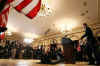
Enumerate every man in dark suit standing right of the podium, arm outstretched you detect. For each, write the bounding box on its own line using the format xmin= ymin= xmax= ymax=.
xmin=81 ymin=23 xmax=96 ymax=65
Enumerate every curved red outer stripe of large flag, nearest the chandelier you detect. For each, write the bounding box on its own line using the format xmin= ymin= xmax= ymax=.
xmin=26 ymin=0 xmax=41 ymax=19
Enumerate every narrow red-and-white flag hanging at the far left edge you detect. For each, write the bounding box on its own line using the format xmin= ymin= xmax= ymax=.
xmin=0 ymin=0 xmax=13 ymax=39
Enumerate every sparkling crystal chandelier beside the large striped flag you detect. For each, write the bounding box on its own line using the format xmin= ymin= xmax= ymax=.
xmin=38 ymin=0 xmax=52 ymax=16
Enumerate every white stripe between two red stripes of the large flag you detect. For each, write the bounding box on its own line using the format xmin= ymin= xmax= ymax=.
xmin=22 ymin=0 xmax=39 ymax=14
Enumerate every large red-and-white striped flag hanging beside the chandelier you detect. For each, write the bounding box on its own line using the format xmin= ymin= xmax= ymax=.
xmin=11 ymin=0 xmax=41 ymax=19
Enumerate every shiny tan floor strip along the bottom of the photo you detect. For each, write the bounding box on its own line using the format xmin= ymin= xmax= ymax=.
xmin=0 ymin=59 xmax=95 ymax=66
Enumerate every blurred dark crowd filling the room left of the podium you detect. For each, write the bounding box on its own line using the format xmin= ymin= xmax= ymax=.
xmin=0 ymin=40 xmax=63 ymax=63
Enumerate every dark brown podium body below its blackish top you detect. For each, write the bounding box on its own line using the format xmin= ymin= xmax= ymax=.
xmin=63 ymin=44 xmax=75 ymax=64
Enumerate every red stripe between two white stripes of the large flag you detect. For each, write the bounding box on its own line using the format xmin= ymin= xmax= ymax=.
xmin=15 ymin=0 xmax=33 ymax=12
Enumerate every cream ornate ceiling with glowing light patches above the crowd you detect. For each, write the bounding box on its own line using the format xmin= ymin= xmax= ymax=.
xmin=7 ymin=0 xmax=98 ymax=38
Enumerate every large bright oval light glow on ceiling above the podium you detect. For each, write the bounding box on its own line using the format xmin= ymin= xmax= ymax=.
xmin=56 ymin=19 xmax=77 ymax=32
